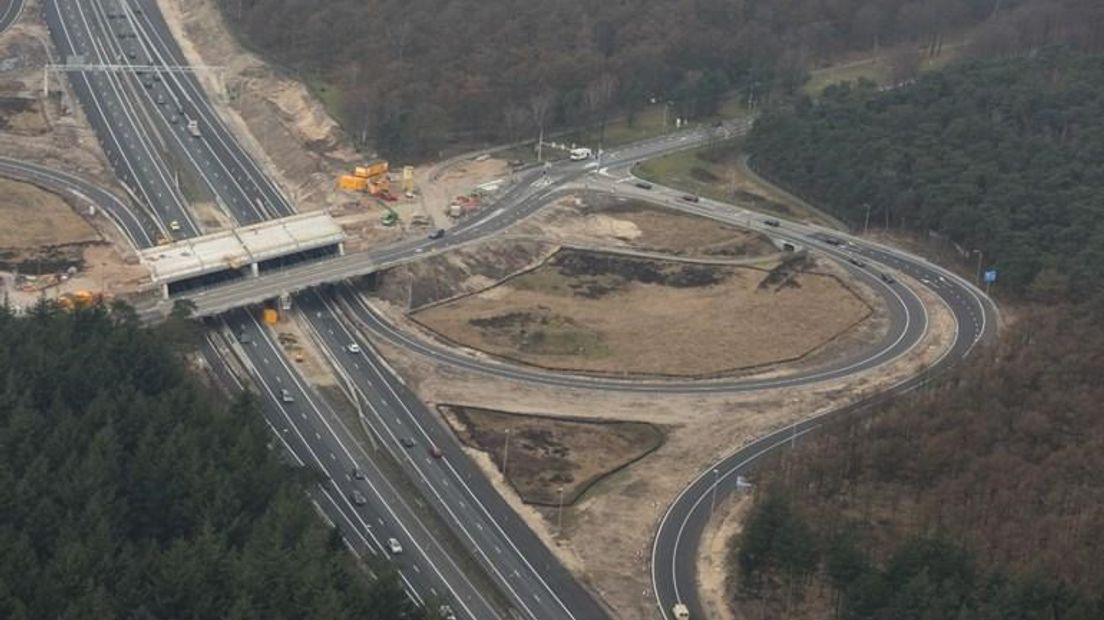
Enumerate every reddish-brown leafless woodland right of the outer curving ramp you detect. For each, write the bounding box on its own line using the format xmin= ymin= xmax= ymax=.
xmin=730 ymin=300 xmax=1104 ymax=620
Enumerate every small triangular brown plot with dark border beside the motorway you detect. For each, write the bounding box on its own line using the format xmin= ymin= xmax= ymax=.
xmin=437 ymin=405 xmax=664 ymax=506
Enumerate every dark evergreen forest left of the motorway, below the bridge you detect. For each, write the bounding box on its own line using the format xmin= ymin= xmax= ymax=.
xmin=0 ymin=306 xmax=422 ymax=620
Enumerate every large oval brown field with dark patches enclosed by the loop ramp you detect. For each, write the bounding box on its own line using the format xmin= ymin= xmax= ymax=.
xmin=412 ymin=249 xmax=872 ymax=376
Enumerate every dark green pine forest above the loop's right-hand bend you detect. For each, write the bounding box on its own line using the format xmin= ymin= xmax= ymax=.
xmin=749 ymin=49 xmax=1104 ymax=301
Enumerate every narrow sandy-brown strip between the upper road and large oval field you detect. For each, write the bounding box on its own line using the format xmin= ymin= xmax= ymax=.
xmin=519 ymin=194 xmax=778 ymax=258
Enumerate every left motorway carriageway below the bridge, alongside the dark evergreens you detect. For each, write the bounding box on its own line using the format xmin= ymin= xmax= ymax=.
xmin=204 ymin=310 xmax=508 ymax=618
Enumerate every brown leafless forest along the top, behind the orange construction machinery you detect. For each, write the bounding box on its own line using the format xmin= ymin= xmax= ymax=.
xmin=219 ymin=0 xmax=1002 ymax=156
